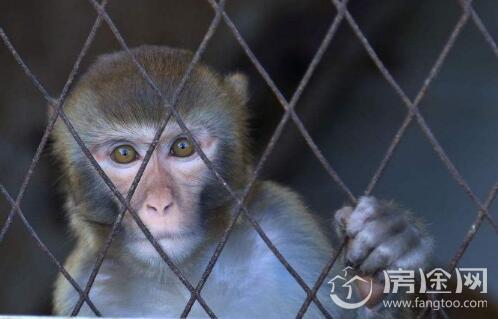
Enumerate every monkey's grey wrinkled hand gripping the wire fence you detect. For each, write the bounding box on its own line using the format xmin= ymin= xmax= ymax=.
xmin=335 ymin=197 xmax=432 ymax=307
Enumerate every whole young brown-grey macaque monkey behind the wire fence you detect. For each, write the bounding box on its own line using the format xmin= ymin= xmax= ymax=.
xmin=53 ymin=46 xmax=431 ymax=318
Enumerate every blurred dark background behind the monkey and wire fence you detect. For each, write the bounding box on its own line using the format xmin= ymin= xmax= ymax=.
xmin=0 ymin=0 xmax=498 ymax=314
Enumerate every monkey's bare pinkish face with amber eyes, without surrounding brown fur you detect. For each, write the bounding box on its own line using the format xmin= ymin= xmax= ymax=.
xmin=92 ymin=124 xmax=218 ymax=258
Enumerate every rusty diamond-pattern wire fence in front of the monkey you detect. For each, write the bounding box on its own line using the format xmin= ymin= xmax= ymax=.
xmin=0 ymin=0 xmax=498 ymax=318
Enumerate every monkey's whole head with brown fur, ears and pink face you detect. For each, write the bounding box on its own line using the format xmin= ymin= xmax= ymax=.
xmin=53 ymin=46 xmax=250 ymax=259
